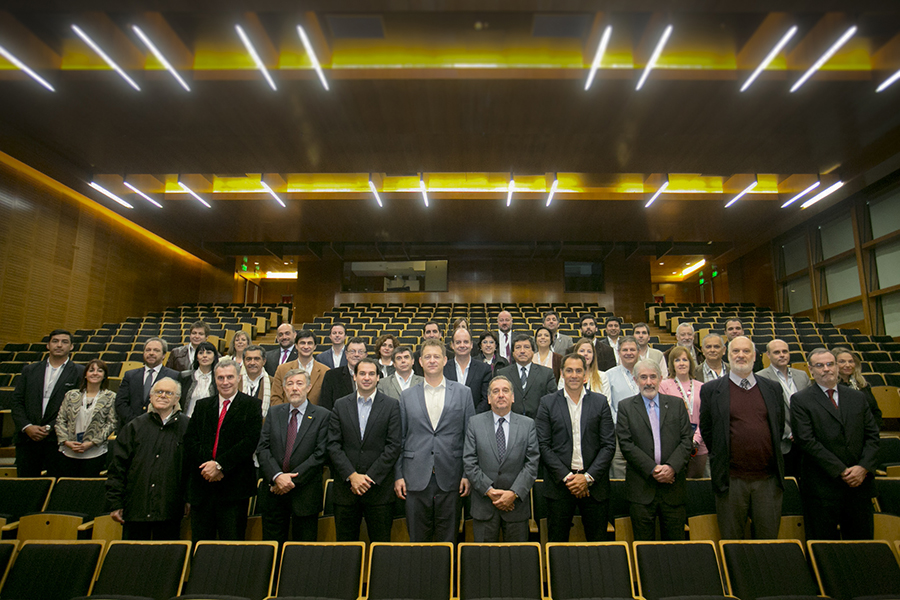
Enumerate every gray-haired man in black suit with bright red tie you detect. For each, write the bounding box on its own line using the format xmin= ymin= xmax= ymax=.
xmin=184 ymin=358 xmax=262 ymax=543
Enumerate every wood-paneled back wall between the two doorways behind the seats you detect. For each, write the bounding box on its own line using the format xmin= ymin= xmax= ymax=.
xmin=284 ymin=251 xmax=653 ymax=324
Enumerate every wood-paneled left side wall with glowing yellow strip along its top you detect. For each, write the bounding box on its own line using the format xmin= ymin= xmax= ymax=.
xmin=0 ymin=155 xmax=234 ymax=348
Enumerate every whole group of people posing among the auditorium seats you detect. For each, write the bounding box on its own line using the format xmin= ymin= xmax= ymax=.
xmin=13 ymin=311 xmax=880 ymax=542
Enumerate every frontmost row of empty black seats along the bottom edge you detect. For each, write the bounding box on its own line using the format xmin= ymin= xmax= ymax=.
xmin=0 ymin=540 xmax=900 ymax=600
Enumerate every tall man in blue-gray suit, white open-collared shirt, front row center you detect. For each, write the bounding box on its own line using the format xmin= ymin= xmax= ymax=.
xmin=394 ymin=339 xmax=475 ymax=542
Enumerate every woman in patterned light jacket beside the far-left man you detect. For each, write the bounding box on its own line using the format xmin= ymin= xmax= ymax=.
xmin=56 ymin=358 xmax=116 ymax=477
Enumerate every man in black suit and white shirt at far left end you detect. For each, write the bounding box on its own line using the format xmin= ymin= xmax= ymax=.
xmin=10 ymin=329 xmax=84 ymax=477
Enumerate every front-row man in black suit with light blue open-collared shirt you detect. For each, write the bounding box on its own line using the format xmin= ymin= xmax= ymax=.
xmin=328 ymin=358 xmax=402 ymax=542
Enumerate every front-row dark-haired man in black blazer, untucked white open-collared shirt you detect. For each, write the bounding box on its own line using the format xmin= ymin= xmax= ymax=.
xmin=536 ymin=354 xmax=616 ymax=542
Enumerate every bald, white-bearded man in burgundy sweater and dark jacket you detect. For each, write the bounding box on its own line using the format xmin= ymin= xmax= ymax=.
xmin=700 ymin=336 xmax=784 ymax=540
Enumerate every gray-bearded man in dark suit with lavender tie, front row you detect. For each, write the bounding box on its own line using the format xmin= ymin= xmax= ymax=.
xmin=616 ymin=359 xmax=694 ymax=541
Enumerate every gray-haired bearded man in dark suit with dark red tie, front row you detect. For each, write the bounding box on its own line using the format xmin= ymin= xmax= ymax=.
xmin=256 ymin=369 xmax=331 ymax=543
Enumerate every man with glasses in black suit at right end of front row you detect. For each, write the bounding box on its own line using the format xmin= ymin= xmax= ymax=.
xmin=791 ymin=348 xmax=879 ymax=540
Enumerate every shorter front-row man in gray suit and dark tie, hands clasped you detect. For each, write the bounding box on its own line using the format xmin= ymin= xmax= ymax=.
xmin=463 ymin=375 xmax=541 ymax=542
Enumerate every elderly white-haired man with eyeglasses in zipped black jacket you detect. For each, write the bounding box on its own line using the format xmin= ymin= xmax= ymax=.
xmin=106 ymin=377 xmax=190 ymax=540
